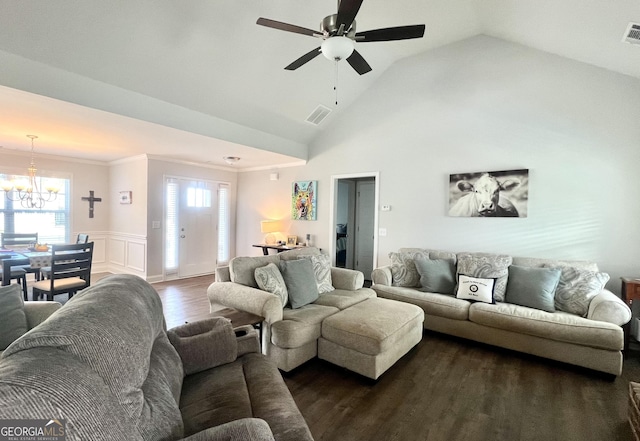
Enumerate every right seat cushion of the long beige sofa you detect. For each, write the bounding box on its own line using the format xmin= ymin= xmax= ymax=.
xmin=469 ymin=303 xmax=624 ymax=351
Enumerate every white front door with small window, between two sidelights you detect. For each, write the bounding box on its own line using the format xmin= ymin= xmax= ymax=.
xmin=177 ymin=179 xmax=218 ymax=278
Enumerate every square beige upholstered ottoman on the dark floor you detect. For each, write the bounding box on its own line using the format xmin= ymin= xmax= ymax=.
xmin=318 ymin=298 xmax=424 ymax=380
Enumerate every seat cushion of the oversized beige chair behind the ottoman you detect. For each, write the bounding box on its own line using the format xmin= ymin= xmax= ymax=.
xmin=271 ymin=304 xmax=340 ymax=349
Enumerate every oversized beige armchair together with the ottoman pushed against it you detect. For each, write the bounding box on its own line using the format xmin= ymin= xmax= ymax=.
xmin=208 ymin=248 xmax=424 ymax=379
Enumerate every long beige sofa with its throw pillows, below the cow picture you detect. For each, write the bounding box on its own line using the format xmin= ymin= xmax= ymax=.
xmin=372 ymin=248 xmax=631 ymax=375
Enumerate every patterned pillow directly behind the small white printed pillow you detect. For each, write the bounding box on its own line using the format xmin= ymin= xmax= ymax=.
xmin=457 ymin=253 xmax=512 ymax=302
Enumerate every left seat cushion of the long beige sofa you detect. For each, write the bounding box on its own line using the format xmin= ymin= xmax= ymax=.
xmin=372 ymin=285 xmax=470 ymax=320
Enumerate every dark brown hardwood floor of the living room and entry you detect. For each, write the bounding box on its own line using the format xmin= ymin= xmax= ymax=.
xmin=27 ymin=276 xmax=640 ymax=441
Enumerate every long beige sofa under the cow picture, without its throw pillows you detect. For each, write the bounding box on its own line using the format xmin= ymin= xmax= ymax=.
xmin=372 ymin=248 xmax=631 ymax=375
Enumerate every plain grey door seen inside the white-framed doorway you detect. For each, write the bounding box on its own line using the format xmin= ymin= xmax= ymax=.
xmin=354 ymin=180 xmax=375 ymax=280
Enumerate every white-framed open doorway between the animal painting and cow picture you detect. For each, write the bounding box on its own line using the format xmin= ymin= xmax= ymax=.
xmin=330 ymin=173 xmax=378 ymax=282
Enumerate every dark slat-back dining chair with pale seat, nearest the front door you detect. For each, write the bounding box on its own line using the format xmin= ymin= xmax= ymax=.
xmin=33 ymin=242 xmax=93 ymax=300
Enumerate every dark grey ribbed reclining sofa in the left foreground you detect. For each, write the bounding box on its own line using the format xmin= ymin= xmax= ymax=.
xmin=0 ymin=275 xmax=313 ymax=441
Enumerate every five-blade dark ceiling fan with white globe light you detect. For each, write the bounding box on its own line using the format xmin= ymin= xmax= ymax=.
xmin=256 ymin=0 xmax=425 ymax=75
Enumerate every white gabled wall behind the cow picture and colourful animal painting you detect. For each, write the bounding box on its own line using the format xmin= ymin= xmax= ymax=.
xmin=237 ymin=36 xmax=640 ymax=292
